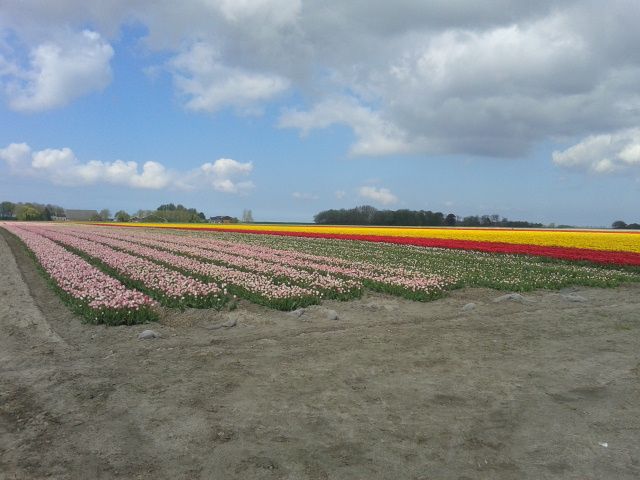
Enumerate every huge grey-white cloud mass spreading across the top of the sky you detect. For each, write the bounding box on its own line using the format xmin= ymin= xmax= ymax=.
xmin=0 ymin=0 xmax=640 ymax=161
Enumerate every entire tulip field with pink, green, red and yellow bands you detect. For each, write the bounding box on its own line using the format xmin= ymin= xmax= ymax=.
xmin=0 ymin=222 xmax=640 ymax=324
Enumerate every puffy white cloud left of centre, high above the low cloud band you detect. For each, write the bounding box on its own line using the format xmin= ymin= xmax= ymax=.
xmin=170 ymin=42 xmax=289 ymax=113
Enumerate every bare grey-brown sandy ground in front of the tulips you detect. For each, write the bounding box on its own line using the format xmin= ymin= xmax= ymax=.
xmin=0 ymin=229 xmax=640 ymax=480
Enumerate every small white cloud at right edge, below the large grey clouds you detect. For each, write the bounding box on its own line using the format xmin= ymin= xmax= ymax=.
xmin=553 ymin=128 xmax=640 ymax=173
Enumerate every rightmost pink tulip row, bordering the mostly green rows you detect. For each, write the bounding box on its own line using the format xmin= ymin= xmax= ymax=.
xmin=97 ymin=228 xmax=456 ymax=296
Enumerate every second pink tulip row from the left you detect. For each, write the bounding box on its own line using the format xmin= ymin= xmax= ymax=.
xmin=28 ymin=227 xmax=226 ymax=307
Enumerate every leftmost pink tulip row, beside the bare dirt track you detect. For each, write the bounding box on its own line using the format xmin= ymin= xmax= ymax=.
xmin=3 ymin=223 xmax=156 ymax=323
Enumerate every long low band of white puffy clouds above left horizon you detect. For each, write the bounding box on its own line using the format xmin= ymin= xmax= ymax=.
xmin=0 ymin=143 xmax=254 ymax=194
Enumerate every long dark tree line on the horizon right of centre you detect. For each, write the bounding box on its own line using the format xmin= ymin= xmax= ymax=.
xmin=313 ymin=205 xmax=544 ymax=228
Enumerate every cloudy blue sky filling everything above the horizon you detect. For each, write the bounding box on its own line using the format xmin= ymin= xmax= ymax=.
xmin=0 ymin=0 xmax=640 ymax=226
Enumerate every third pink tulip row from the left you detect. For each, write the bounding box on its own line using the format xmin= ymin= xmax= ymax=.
xmin=40 ymin=227 xmax=323 ymax=309
